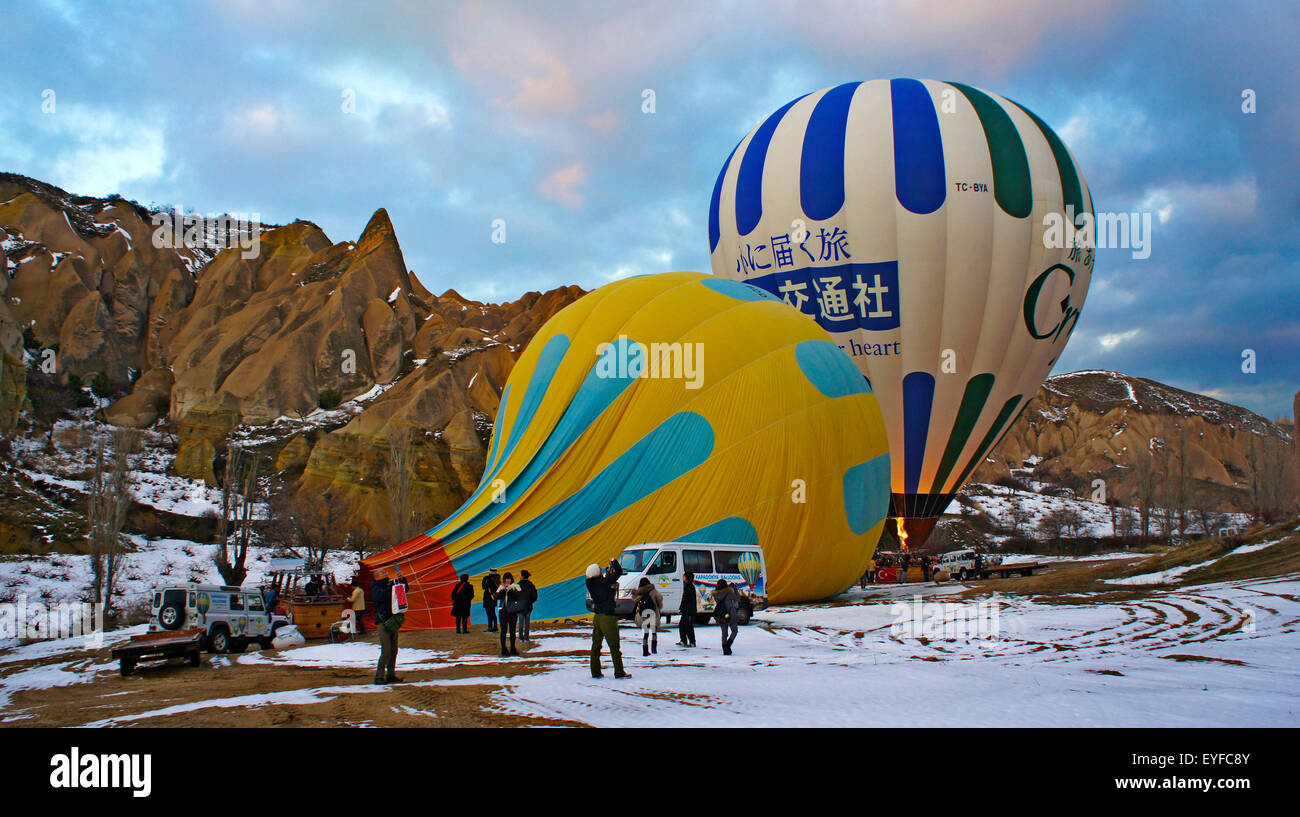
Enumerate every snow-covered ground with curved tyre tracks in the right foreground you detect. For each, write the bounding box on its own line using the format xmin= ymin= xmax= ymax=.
xmin=475 ymin=579 xmax=1300 ymax=726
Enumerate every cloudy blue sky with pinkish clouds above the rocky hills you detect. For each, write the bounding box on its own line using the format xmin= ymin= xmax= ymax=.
xmin=0 ymin=0 xmax=1300 ymax=418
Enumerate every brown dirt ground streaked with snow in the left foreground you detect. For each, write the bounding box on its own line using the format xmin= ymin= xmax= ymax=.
xmin=0 ymin=624 xmax=582 ymax=727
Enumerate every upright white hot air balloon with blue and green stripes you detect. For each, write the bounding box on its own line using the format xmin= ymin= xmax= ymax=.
xmin=709 ymin=79 xmax=1093 ymax=544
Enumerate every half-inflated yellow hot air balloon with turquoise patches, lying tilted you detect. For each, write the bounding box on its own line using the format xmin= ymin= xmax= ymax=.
xmin=363 ymin=272 xmax=889 ymax=628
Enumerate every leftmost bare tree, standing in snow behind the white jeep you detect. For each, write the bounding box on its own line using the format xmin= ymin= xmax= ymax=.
xmin=86 ymin=428 xmax=137 ymax=609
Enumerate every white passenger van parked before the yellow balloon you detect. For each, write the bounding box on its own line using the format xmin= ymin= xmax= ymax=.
xmin=586 ymin=542 xmax=767 ymax=624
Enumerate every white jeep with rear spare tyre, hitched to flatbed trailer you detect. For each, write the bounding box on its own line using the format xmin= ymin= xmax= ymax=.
xmin=150 ymin=582 xmax=289 ymax=653
